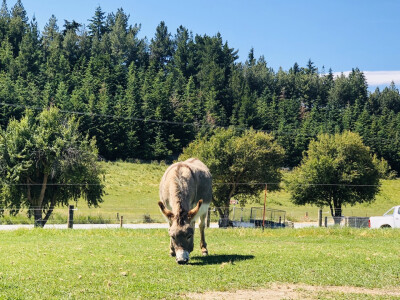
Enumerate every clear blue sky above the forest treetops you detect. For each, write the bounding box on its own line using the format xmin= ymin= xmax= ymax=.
xmin=7 ymin=0 xmax=400 ymax=86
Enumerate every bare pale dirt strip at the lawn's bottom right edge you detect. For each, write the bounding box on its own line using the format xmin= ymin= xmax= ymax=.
xmin=185 ymin=283 xmax=400 ymax=300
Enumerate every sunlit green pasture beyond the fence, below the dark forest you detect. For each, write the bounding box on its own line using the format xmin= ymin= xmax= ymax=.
xmin=0 ymin=162 xmax=400 ymax=223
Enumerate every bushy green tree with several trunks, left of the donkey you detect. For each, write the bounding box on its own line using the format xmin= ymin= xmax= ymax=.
xmin=0 ymin=107 xmax=104 ymax=227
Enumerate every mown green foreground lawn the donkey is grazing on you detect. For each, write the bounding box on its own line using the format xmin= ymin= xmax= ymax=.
xmin=0 ymin=228 xmax=400 ymax=299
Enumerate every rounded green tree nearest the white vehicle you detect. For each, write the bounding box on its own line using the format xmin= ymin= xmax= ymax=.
xmin=286 ymin=131 xmax=380 ymax=217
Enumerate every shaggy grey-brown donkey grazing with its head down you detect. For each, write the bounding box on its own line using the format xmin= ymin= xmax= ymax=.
xmin=158 ymin=158 xmax=212 ymax=264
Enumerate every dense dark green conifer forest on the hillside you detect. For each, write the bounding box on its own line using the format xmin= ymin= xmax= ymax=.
xmin=0 ymin=0 xmax=400 ymax=171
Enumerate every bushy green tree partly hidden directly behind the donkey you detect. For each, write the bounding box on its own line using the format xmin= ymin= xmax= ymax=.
xmin=179 ymin=129 xmax=284 ymax=219
